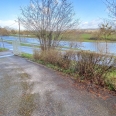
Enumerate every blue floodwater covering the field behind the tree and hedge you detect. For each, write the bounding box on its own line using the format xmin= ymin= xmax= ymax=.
xmin=0 ymin=36 xmax=116 ymax=55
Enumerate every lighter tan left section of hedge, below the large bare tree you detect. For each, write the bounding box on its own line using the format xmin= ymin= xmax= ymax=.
xmin=33 ymin=49 xmax=75 ymax=69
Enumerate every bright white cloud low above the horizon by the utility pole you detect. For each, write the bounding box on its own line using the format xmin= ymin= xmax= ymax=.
xmin=0 ymin=20 xmax=24 ymax=30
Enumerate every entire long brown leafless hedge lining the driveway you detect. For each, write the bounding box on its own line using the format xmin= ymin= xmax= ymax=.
xmin=34 ymin=49 xmax=116 ymax=88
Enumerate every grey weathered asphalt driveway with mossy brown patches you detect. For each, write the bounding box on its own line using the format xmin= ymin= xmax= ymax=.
xmin=0 ymin=53 xmax=116 ymax=116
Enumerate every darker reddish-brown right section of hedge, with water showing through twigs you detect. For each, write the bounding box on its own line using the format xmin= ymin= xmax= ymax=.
xmin=75 ymin=51 xmax=115 ymax=85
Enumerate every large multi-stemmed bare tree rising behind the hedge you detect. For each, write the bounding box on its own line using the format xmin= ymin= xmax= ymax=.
xmin=20 ymin=0 xmax=79 ymax=50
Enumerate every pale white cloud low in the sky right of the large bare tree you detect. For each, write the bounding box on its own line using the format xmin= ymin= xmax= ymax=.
xmin=80 ymin=19 xmax=102 ymax=29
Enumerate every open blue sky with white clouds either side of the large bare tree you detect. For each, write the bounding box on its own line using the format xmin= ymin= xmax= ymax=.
xmin=0 ymin=0 xmax=108 ymax=29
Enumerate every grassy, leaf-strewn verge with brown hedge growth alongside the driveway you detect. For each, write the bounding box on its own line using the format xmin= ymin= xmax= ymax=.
xmin=21 ymin=51 xmax=116 ymax=91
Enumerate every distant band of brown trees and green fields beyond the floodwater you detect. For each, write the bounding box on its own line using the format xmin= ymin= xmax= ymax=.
xmin=0 ymin=27 xmax=116 ymax=41
